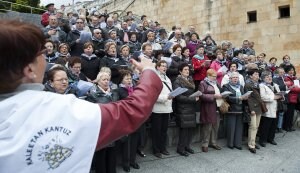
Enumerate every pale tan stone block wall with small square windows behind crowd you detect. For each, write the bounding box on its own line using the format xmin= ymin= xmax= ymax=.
xmin=108 ymin=0 xmax=300 ymax=74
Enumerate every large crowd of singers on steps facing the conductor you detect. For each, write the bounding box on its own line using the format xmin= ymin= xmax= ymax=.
xmin=41 ymin=4 xmax=300 ymax=173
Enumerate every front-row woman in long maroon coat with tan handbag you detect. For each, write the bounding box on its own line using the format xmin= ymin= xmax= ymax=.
xmin=199 ymin=69 xmax=223 ymax=152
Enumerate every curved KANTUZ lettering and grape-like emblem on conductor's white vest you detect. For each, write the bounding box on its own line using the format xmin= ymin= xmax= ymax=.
xmin=25 ymin=126 xmax=73 ymax=169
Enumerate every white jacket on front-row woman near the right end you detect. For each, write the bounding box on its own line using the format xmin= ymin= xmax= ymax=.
xmin=259 ymin=83 xmax=280 ymax=118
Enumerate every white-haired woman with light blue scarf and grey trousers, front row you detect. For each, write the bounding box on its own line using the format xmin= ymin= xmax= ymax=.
xmin=222 ymin=72 xmax=248 ymax=150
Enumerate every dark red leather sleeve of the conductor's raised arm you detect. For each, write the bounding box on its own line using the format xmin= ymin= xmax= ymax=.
xmin=97 ymin=70 xmax=163 ymax=150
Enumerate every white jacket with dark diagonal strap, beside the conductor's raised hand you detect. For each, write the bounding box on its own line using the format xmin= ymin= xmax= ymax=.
xmin=152 ymin=72 xmax=173 ymax=113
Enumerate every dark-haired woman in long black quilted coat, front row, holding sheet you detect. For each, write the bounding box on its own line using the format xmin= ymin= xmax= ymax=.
xmin=173 ymin=63 xmax=199 ymax=156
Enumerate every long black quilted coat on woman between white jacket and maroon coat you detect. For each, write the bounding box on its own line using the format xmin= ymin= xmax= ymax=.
xmin=173 ymin=76 xmax=197 ymax=128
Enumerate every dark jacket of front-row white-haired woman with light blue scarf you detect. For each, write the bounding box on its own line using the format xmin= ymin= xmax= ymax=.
xmin=222 ymin=84 xmax=245 ymax=112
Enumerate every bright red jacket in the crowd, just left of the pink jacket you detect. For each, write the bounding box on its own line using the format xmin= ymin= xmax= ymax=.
xmin=192 ymin=55 xmax=209 ymax=81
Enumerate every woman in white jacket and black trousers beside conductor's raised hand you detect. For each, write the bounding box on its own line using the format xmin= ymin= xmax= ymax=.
xmin=151 ymin=60 xmax=173 ymax=158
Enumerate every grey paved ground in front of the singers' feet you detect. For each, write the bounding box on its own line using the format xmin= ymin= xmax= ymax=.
xmin=118 ymin=129 xmax=300 ymax=173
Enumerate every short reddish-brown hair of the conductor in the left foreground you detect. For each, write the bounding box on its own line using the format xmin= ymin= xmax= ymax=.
xmin=0 ymin=20 xmax=45 ymax=94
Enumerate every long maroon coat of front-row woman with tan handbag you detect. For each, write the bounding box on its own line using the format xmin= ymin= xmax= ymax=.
xmin=199 ymin=80 xmax=220 ymax=124
